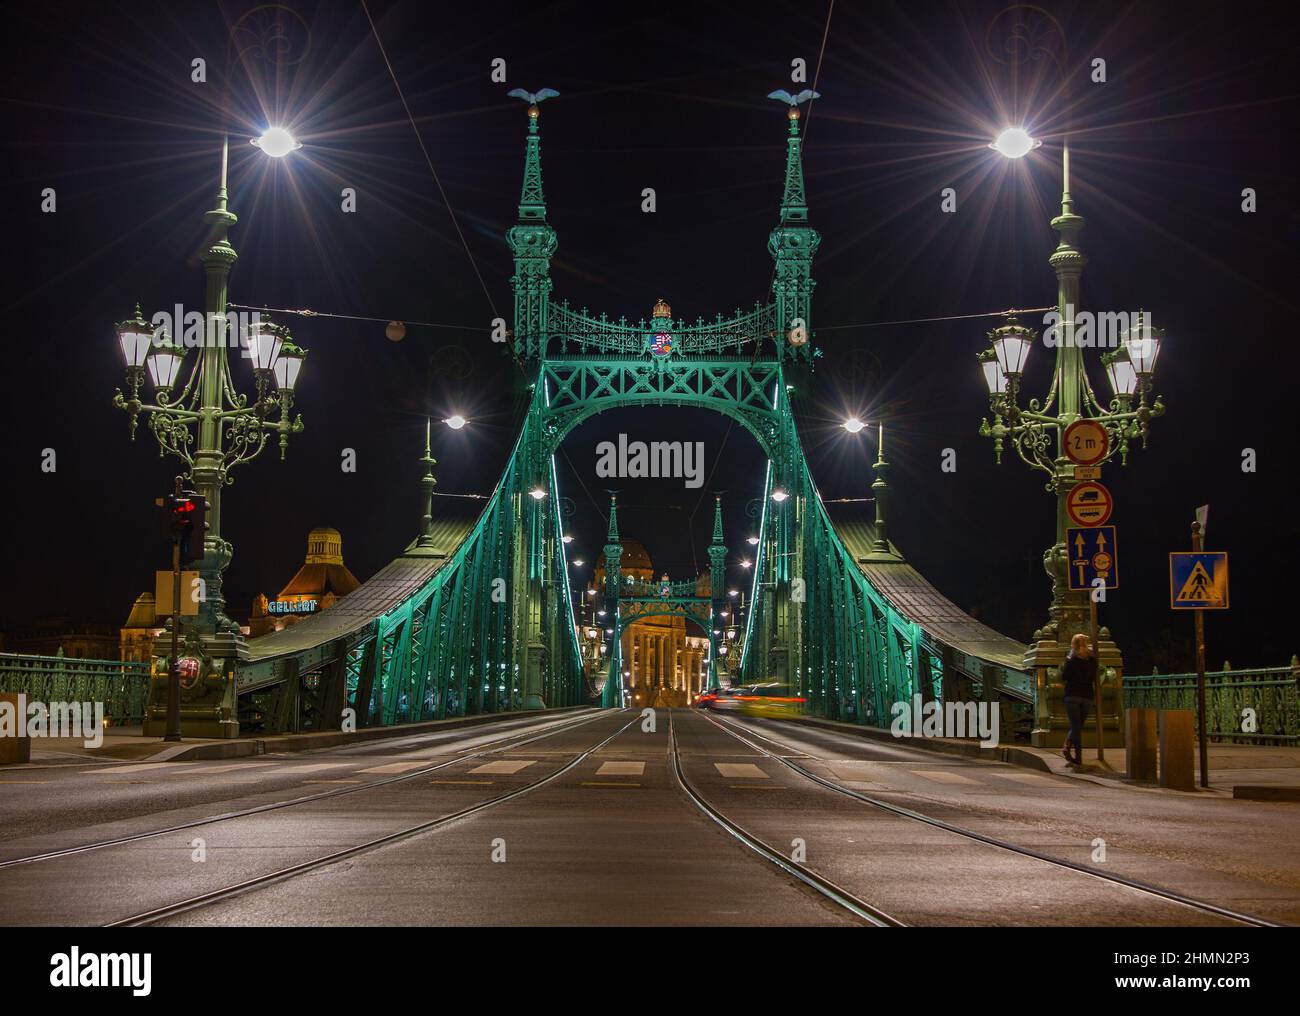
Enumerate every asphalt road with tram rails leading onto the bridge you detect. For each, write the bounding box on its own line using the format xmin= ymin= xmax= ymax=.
xmin=0 ymin=709 xmax=1300 ymax=926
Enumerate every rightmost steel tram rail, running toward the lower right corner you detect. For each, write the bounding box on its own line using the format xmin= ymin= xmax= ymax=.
xmin=706 ymin=713 xmax=1286 ymax=928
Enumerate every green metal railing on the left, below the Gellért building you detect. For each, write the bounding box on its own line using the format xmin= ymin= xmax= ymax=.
xmin=0 ymin=652 xmax=152 ymax=726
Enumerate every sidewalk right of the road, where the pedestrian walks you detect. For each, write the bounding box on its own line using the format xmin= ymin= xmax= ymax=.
xmin=780 ymin=716 xmax=1300 ymax=802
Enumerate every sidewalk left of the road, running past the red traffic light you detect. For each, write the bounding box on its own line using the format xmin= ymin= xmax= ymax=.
xmin=0 ymin=705 xmax=592 ymax=770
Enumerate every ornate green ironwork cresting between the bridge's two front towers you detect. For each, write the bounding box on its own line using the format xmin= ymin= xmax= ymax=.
xmin=543 ymin=301 xmax=776 ymax=356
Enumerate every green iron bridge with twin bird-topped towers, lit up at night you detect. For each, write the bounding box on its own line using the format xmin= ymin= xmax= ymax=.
xmin=237 ymin=93 xmax=1035 ymax=729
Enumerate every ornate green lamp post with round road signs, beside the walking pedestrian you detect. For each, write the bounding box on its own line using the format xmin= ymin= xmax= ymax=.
xmin=978 ymin=131 xmax=1165 ymax=746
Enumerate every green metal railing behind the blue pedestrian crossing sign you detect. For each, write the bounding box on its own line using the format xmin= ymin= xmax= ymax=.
xmin=1125 ymin=661 xmax=1300 ymax=744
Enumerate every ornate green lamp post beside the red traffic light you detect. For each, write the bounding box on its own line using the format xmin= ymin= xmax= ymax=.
xmin=113 ymin=129 xmax=307 ymax=737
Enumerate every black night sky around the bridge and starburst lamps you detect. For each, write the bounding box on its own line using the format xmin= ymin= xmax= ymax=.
xmin=0 ymin=0 xmax=1300 ymax=673
